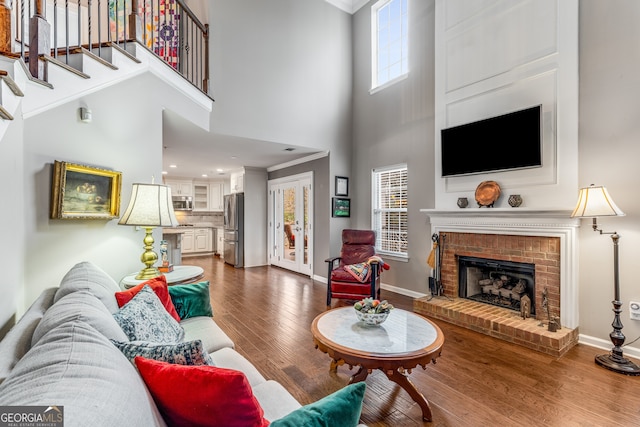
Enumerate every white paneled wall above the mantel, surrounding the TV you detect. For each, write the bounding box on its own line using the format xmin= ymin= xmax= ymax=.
xmin=434 ymin=0 xmax=578 ymax=209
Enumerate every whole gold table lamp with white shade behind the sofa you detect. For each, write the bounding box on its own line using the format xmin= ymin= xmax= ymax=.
xmin=118 ymin=184 xmax=178 ymax=280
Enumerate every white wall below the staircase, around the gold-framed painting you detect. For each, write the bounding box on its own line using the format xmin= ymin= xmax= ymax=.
xmin=19 ymin=73 xmax=208 ymax=313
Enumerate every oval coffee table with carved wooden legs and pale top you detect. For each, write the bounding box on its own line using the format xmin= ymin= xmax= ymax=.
xmin=311 ymin=307 xmax=444 ymax=421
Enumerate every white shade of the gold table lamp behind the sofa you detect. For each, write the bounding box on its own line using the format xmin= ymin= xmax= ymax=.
xmin=118 ymin=184 xmax=178 ymax=227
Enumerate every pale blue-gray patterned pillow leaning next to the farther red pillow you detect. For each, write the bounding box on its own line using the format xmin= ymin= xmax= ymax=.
xmin=113 ymin=286 xmax=184 ymax=344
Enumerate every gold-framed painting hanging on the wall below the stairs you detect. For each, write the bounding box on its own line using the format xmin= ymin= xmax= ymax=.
xmin=50 ymin=160 xmax=122 ymax=220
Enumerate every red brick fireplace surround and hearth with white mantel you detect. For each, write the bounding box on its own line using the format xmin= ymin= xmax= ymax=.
xmin=414 ymin=208 xmax=579 ymax=356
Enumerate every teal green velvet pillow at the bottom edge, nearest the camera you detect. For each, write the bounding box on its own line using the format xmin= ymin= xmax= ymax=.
xmin=270 ymin=382 xmax=366 ymax=427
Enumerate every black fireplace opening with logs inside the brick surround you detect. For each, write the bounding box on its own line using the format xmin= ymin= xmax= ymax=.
xmin=458 ymin=256 xmax=536 ymax=317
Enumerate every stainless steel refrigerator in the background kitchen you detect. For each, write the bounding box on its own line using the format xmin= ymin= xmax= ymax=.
xmin=224 ymin=193 xmax=244 ymax=268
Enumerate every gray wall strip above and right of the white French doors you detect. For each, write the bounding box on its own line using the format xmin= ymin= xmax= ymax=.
xmin=269 ymin=156 xmax=330 ymax=277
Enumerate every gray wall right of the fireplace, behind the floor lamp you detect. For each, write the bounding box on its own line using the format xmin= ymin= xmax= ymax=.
xmin=576 ymin=0 xmax=640 ymax=348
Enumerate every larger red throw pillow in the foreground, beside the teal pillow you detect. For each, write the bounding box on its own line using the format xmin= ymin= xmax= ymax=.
xmin=134 ymin=356 xmax=269 ymax=427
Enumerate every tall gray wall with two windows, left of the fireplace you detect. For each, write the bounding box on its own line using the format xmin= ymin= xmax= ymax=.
xmin=349 ymin=0 xmax=435 ymax=293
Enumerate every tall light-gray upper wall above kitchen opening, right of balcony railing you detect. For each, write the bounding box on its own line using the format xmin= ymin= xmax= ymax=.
xmin=209 ymin=0 xmax=352 ymax=258
